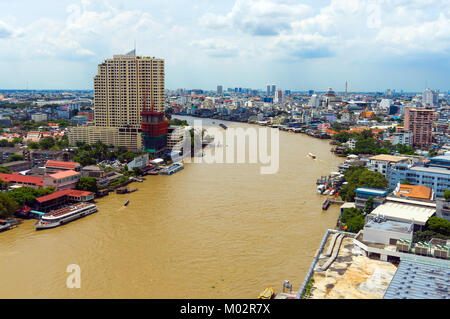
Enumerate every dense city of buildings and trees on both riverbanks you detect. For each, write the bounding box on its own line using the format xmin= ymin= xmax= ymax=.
xmin=0 ymin=52 xmax=450 ymax=299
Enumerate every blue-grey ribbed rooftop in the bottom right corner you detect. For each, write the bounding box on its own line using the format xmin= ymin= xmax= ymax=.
xmin=383 ymin=256 xmax=450 ymax=299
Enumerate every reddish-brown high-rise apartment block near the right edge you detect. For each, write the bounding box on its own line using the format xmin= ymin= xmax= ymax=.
xmin=404 ymin=107 xmax=434 ymax=146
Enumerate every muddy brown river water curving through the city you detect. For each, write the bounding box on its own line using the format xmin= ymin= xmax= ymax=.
xmin=0 ymin=117 xmax=342 ymax=298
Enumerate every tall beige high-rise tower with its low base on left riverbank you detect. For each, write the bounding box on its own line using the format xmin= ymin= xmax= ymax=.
xmin=69 ymin=50 xmax=167 ymax=151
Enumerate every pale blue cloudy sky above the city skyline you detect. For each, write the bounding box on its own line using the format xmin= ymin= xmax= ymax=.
xmin=0 ymin=0 xmax=450 ymax=92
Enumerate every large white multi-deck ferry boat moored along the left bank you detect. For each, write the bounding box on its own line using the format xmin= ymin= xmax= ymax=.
xmin=34 ymin=203 xmax=97 ymax=230
